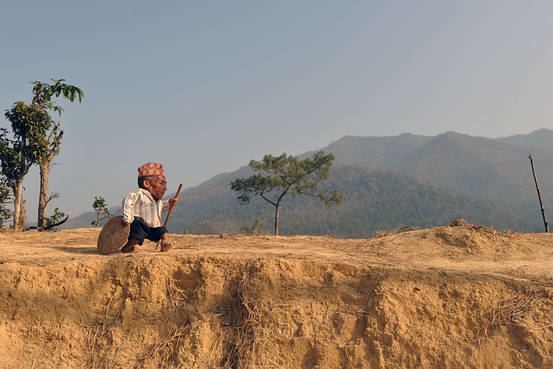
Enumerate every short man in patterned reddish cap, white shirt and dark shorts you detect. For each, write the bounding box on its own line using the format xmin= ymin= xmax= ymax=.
xmin=121 ymin=162 xmax=178 ymax=253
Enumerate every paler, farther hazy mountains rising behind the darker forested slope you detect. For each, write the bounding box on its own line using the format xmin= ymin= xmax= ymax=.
xmin=324 ymin=129 xmax=553 ymax=229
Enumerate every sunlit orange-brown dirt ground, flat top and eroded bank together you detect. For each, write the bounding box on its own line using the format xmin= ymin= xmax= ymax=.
xmin=0 ymin=222 xmax=553 ymax=369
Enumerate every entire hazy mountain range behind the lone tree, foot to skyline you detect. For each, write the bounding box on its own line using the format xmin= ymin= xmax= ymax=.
xmin=68 ymin=129 xmax=553 ymax=237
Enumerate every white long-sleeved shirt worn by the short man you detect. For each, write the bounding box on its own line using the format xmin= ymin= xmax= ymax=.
xmin=123 ymin=188 xmax=169 ymax=227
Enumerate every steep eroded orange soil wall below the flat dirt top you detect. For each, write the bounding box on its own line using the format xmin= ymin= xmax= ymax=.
xmin=0 ymin=256 xmax=553 ymax=369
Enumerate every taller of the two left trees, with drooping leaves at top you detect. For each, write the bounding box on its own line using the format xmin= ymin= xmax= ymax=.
xmin=32 ymin=79 xmax=84 ymax=231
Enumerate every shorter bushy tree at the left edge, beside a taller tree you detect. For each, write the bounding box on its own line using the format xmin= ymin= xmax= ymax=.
xmin=0 ymin=101 xmax=52 ymax=230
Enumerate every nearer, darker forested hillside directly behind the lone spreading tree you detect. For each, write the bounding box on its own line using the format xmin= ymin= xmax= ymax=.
xmin=172 ymin=166 xmax=528 ymax=237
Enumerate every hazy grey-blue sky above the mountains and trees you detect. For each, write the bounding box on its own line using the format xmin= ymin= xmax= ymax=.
xmin=0 ymin=0 xmax=553 ymax=216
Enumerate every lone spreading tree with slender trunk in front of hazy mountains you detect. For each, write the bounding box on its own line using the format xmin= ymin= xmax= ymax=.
xmin=231 ymin=151 xmax=343 ymax=235
